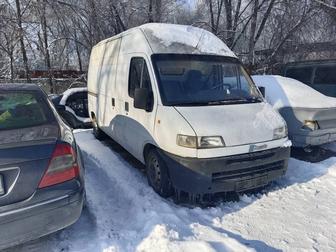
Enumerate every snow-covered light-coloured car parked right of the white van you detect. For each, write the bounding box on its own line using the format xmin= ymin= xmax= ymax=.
xmin=252 ymin=75 xmax=336 ymax=148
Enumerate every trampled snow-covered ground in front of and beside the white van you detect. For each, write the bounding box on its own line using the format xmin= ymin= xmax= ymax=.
xmin=7 ymin=131 xmax=336 ymax=252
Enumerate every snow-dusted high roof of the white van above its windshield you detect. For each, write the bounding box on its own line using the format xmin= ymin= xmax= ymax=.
xmin=94 ymin=23 xmax=237 ymax=58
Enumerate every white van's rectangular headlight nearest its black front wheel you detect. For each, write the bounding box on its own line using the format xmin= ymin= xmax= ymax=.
xmin=176 ymin=134 xmax=225 ymax=149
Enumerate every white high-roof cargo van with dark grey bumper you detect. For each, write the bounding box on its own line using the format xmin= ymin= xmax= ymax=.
xmin=88 ymin=24 xmax=290 ymax=197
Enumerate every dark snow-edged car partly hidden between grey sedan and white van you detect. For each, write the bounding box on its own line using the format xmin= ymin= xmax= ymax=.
xmin=49 ymin=87 xmax=91 ymax=128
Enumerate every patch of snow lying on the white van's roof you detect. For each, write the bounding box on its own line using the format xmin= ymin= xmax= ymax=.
xmin=140 ymin=23 xmax=237 ymax=58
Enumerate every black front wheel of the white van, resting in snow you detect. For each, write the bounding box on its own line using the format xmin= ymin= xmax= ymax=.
xmin=146 ymin=149 xmax=173 ymax=198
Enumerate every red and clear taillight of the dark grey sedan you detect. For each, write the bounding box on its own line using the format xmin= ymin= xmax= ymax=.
xmin=38 ymin=143 xmax=79 ymax=188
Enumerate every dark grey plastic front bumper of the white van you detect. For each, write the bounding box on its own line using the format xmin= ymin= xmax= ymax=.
xmin=161 ymin=147 xmax=290 ymax=195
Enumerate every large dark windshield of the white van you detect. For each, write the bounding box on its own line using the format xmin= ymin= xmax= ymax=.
xmin=152 ymin=54 xmax=263 ymax=106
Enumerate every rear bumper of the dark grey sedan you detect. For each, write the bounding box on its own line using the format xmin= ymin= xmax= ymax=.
xmin=0 ymin=182 xmax=85 ymax=249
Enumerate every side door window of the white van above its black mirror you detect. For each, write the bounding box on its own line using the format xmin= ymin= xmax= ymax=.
xmin=128 ymin=57 xmax=152 ymax=98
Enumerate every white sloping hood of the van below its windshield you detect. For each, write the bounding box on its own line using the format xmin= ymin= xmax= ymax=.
xmin=175 ymin=102 xmax=285 ymax=146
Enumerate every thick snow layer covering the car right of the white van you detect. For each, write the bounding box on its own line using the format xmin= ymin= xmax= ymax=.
xmin=252 ymin=75 xmax=336 ymax=109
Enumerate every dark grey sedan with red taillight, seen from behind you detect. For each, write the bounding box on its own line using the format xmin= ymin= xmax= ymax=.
xmin=0 ymin=84 xmax=85 ymax=249
